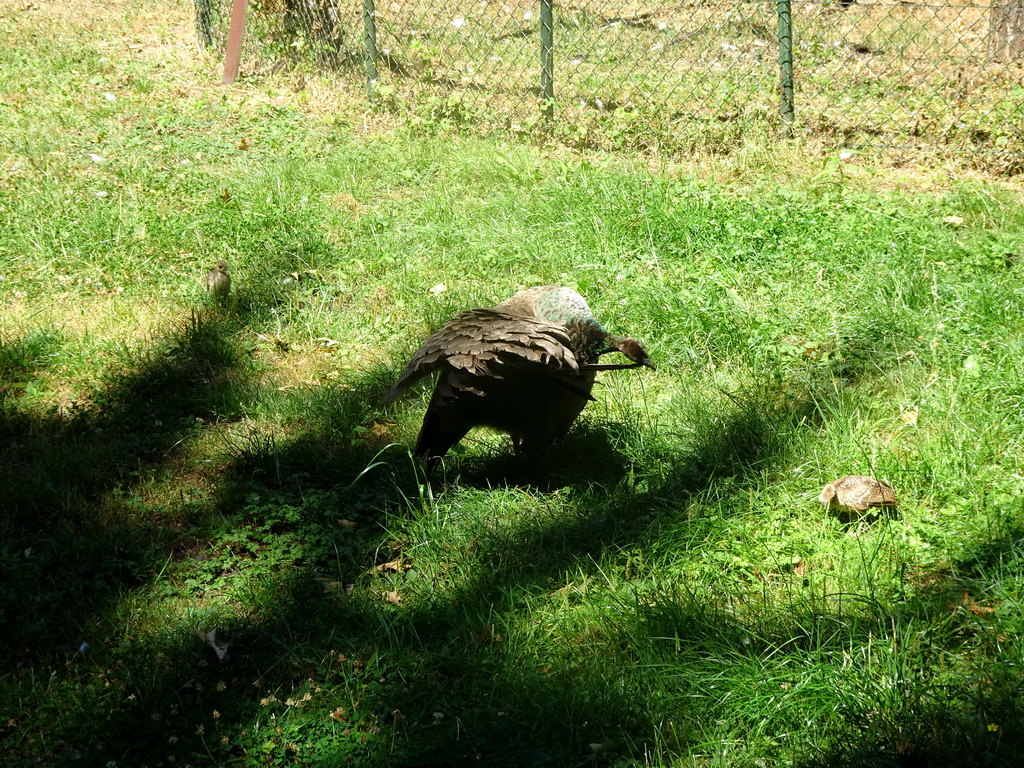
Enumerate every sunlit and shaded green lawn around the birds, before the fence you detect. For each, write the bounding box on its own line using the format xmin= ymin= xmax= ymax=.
xmin=0 ymin=2 xmax=1024 ymax=766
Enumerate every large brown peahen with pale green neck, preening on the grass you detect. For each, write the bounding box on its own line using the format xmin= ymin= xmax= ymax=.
xmin=385 ymin=286 xmax=655 ymax=466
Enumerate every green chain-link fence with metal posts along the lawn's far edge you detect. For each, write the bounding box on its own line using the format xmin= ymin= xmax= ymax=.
xmin=196 ymin=0 xmax=1024 ymax=153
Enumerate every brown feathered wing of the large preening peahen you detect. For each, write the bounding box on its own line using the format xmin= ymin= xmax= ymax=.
xmin=385 ymin=309 xmax=580 ymax=402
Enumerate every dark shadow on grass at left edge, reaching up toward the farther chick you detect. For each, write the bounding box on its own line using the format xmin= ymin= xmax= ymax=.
xmin=0 ymin=315 xmax=264 ymax=658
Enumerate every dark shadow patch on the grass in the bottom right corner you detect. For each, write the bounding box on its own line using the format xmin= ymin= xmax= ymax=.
xmin=803 ymin=517 xmax=1024 ymax=768
